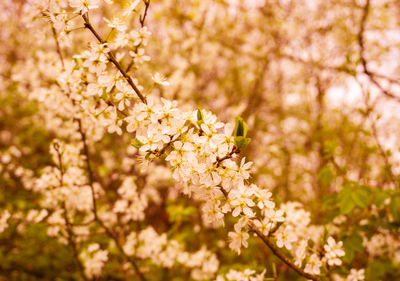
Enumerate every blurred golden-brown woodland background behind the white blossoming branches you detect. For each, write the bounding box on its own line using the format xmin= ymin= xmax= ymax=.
xmin=0 ymin=0 xmax=400 ymax=280
